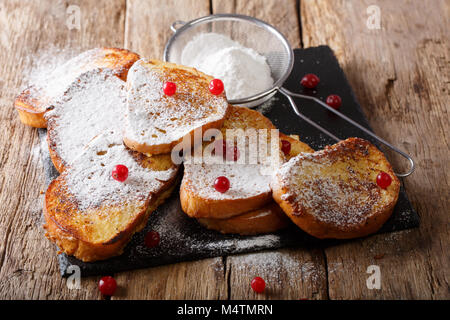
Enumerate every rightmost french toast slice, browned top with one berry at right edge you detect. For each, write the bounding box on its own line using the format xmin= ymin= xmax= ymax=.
xmin=272 ymin=138 xmax=400 ymax=239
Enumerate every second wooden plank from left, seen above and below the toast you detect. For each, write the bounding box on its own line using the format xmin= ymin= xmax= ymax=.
xmin=113 ymin=0 xmax=227 ymax=299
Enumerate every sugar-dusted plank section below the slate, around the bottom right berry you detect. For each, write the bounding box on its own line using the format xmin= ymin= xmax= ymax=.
xmin=227 ymin=249 xmax=327 ymax=300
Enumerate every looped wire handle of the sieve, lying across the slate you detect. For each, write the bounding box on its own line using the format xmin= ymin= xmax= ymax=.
xmin=279 ymin=88 xmax=415 ymax=178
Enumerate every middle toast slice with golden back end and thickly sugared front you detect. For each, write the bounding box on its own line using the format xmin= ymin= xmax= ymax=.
xmin=180 ymin=106 xmax=313 ymax=219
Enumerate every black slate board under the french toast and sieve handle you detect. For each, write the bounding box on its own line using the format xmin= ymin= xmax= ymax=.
xmin=39 ymin=46 xmax=419 ymax=276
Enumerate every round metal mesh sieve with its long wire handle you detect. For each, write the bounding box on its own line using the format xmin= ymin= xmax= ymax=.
xmin=164 ymin=14 xmax=415 ymax=177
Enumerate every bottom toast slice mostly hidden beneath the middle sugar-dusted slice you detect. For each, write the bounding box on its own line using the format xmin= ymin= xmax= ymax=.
xmin=197 ymin=201 xmax=290 ymax=236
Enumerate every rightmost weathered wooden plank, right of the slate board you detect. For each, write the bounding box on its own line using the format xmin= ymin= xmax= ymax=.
xmin=300 ymin=0 xmax=450 ymax=299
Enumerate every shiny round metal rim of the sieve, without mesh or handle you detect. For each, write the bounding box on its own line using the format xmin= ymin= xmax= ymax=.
xmin=163 ymin=13 xmax=294 ymax=104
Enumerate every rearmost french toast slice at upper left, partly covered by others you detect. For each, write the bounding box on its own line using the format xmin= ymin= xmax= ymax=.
xmin=14 ymin=48 xmax=139 ymax=128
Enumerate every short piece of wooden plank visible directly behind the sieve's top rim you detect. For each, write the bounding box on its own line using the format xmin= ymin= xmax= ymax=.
xmin=212 ymin=0 xmax=301 ymax=48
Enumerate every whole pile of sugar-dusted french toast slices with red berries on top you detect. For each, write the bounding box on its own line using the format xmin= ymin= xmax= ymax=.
xmin=15 ymin=48 xmax=400 ymax=261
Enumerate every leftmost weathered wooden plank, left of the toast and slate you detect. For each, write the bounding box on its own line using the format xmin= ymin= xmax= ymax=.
xmin=0 ymin=0 xmax=125 ymax=299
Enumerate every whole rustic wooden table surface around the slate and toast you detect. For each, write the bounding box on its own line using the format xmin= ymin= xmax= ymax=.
xmin=0 ymin=0 xmax=450 ymax=299
